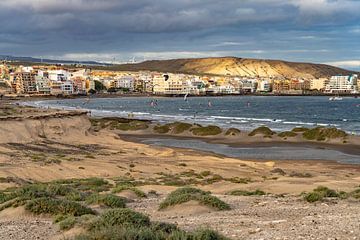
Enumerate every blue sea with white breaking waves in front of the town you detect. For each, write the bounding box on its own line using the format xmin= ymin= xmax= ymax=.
xmin=27 ymin=96 xmax=360 ymax=135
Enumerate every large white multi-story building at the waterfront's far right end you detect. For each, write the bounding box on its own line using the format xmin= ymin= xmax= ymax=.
xmin=325 ymin=74 xmax=358 ymax=94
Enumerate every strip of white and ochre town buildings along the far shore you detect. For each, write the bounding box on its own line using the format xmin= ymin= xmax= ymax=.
xmin=0 ymin=62 xmax=360 ymax=96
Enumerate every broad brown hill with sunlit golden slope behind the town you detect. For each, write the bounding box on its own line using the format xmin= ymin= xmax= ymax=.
xmin=108 ymin=57 xmax=354 ymax=78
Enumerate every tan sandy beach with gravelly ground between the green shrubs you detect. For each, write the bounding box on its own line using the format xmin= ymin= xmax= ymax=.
xmin=0 ymin=103 xmax=360 ymax=239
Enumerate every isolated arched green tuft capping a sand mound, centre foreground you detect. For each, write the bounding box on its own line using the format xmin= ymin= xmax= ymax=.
xmin=159 ymin=187 xmax=230 ymax=210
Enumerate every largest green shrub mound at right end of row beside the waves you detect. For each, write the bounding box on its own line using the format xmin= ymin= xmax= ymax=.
xmin=303 ymin=127 xmax=347 ymax=141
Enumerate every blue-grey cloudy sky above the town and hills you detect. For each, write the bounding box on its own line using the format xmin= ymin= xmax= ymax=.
xmin=0 ymin=0 xmax=360 ymax=70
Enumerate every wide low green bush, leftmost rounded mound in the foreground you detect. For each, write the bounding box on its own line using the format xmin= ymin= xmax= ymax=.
xmin=25 ymin=198 xmax=95 ymax=216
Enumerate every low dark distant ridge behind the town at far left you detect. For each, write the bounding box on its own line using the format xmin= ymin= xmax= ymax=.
xmin=0 ymin=55 xmax=110 ymax=66
